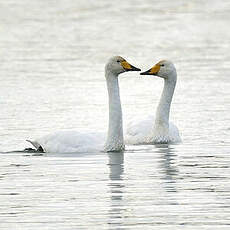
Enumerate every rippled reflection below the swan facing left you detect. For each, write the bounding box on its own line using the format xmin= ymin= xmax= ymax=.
xmin=156 ymin=144 xmax=178 ymax=192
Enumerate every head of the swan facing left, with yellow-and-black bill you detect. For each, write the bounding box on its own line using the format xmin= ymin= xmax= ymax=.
xmin=140 ymin=60 xmax=176 ymax=80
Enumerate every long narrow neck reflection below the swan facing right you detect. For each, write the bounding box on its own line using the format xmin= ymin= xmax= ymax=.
xmin=108 ymin=153 xmax=124 ymax=226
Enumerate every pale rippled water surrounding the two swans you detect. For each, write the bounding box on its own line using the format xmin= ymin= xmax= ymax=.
xmin=0 ymin=0 xmax=230 ymax=230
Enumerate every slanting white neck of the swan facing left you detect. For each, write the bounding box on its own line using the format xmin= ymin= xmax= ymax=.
xmin=154 ymin=75 xmax=176 ymax=131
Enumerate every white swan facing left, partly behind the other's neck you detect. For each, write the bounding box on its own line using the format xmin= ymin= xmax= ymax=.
xmin=125 ymin=60 xmax=181 ymax=144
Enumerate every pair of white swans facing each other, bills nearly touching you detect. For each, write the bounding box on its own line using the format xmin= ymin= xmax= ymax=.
xmin=27 ymin=56 xmax=181 ymax=153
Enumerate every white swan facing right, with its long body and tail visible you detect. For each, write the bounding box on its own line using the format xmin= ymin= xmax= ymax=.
xmin=27 ymin=56 xmax=140 ymax=153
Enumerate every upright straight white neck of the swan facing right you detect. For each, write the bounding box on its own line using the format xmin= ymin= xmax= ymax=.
xmin=105 ymin=71 xmax=124 ymax=152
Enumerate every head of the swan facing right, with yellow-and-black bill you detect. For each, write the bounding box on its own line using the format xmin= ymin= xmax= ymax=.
xmin=105 ymin=56 xmax=141 ymax=76
